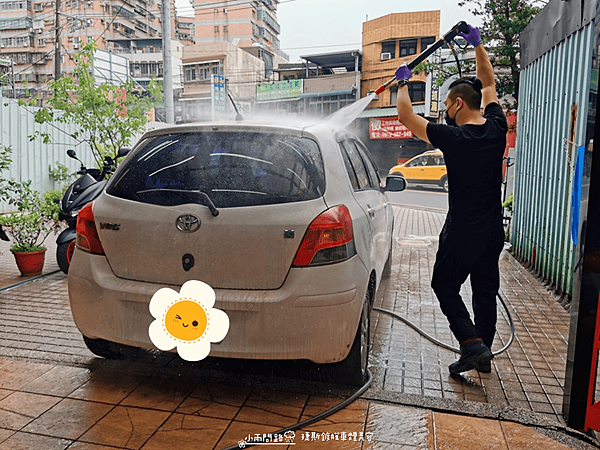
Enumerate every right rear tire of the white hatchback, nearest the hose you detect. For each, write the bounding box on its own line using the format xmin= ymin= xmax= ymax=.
xmin=332 ymin=289 xmax=371 ymax=386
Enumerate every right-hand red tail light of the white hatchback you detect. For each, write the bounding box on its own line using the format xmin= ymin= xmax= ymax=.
xmin=292 ymin=205 xmax=356 ymax=267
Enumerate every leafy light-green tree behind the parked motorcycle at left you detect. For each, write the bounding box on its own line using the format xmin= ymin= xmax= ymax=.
xmin=30 ymin=41 xmax=162 ymax=164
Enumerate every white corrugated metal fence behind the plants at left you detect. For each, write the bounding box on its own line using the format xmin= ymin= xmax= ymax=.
xmin=0 ymin=98 xmax=94 ymax=212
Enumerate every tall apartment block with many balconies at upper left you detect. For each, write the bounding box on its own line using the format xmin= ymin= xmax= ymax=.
xmin=0 ymin=0 xmax=188 ymax=97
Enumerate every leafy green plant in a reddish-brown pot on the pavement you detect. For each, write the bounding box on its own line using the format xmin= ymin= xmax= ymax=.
xmin=0 ymin=180 xmax=58 ymax=276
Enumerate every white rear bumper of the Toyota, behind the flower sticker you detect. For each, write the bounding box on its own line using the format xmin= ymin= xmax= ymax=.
xmin=68 ymin=249 xmax=369 ymax=363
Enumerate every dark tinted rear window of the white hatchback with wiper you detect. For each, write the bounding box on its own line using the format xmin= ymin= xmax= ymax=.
xmin=107 ymin=132 xmax=325 ymax=208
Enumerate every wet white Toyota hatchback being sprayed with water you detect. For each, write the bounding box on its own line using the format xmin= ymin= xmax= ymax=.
xmin=68 ymin=122 xmax=406 ymax=384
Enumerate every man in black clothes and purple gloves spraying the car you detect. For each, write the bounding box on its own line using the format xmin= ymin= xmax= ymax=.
xmin=396 ymin=27 xmax=507 ymax=374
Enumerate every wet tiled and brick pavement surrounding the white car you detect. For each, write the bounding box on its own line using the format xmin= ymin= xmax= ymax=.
xmin=0 ymin=206 xmax=595 ymax=450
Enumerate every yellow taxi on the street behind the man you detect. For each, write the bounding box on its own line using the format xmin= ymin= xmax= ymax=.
xmin=389 ymin=150 xmax=448 ymax=192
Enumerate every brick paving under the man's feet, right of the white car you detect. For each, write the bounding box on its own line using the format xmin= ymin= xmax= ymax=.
xmin=371 ymin=208 xmax=569 ymax=423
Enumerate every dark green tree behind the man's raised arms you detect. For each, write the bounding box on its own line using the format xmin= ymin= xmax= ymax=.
xmin=458 ymin=0 xmax=543 ymax=101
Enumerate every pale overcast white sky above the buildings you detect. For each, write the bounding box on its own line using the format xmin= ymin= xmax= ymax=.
xmin=175 ymin=0 xmax=481 ymax=62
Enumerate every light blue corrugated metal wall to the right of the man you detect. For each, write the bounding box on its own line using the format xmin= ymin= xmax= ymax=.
xmin=511 ymin=23 xmax=594 ymax=294
